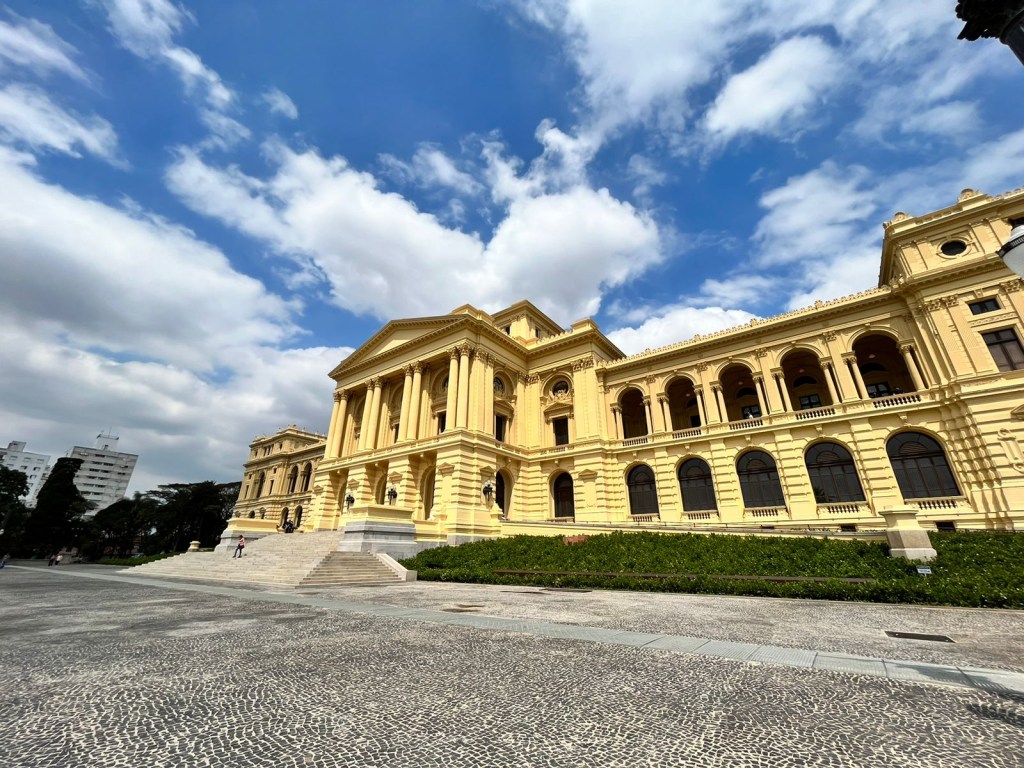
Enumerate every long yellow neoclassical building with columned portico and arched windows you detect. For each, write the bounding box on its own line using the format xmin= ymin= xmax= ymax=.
xmin=225 ymin=189 xmax=1024 ymax=554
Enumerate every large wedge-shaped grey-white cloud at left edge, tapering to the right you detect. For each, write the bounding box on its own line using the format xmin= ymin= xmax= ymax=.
xmin=0 ymin=150 xmax=298 ymax=371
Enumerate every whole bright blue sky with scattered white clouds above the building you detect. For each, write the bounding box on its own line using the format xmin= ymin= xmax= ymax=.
xmin=0 ymin=0 xmax=1024 ymax=489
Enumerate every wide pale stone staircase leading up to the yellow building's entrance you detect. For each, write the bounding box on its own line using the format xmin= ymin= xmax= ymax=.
xmin=128 ymin=530 xmax=404 ymax=589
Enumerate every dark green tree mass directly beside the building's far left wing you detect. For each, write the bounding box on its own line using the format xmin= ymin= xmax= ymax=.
xmin=146 ymin=480 xmax=241 ymax=552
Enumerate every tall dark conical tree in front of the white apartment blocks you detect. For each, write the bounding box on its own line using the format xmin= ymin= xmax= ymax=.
xmin=25 ymin=457 xmax=91 ymax=555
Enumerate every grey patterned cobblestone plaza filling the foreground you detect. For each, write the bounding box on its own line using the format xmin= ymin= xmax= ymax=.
xmin=0 ymin=566 xmax=1024 ymax=768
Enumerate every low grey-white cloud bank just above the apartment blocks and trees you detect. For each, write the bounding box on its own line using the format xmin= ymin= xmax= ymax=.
xmin=0 ymin=324 xmax=352 ymax=490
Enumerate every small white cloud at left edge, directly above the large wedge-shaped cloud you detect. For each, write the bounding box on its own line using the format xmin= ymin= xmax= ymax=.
xmin=0 ymin=85 xmax=122 ymax=165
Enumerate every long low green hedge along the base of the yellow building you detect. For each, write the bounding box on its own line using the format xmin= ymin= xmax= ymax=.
xmin=402 ymin=531 xmax=1024 ymax=608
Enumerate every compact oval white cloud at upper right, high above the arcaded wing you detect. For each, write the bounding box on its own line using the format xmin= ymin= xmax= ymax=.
xmin=706 ymin=37 xmax=840 ymax=141
